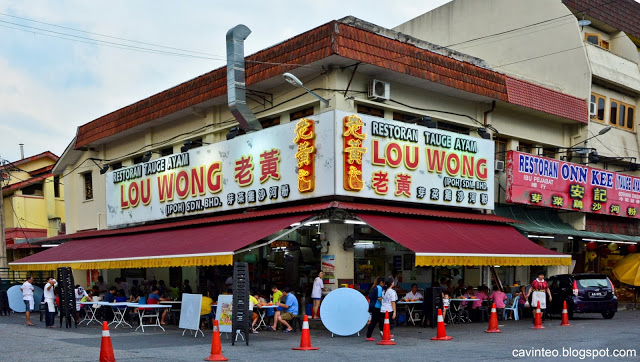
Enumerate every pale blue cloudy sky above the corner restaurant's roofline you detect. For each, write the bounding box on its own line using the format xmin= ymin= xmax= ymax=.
xmin=0 ymin=0 xmax=448 ymax=161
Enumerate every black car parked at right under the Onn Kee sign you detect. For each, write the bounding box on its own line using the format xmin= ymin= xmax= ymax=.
xmin=547 ymin=274 xmax=618 ymax=319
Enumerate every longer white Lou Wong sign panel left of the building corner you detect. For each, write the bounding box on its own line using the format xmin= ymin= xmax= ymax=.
xmin=106 ymin=113 xmax=334 ymax=227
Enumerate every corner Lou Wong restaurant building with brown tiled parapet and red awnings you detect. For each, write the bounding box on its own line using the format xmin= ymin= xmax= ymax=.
xmin=11 ymin=17 xmax=588 ymax=292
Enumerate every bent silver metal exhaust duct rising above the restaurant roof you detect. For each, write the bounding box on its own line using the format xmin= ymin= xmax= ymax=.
xmin=227 ymin=24 xmax=262 ymax=132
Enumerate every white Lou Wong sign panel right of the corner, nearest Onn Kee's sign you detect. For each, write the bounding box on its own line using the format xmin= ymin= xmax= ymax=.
xmin=335 ymin=111 xmax=494 ymax=209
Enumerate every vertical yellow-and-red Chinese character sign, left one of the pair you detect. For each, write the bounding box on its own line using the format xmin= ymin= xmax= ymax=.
xmin=293 ymin=118 xmax=316 ymax=193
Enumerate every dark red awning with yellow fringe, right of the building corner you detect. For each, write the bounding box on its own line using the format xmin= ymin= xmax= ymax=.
xmin=357 ymin=213 xmax=571 ymax=266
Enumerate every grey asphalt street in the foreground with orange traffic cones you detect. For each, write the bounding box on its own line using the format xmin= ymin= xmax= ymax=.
xmin=0 ymin=311 xmax=640 ymax=362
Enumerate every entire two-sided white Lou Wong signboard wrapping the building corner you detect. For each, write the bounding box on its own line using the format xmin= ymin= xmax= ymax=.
xmin=106 ymin=111 xmax=494 ymax=227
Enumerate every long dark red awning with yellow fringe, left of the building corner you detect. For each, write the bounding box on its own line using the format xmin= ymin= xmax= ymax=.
xmin=10 ymin=214 xmax=309 ymax=270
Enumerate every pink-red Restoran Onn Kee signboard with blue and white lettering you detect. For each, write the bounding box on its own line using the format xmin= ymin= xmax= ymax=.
xmin=506 ymin=151 xmax=640 ymax=218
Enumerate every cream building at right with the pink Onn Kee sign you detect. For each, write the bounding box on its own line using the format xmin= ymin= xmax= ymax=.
xmin=394 ymin=0 xmax=640 ymax=296
